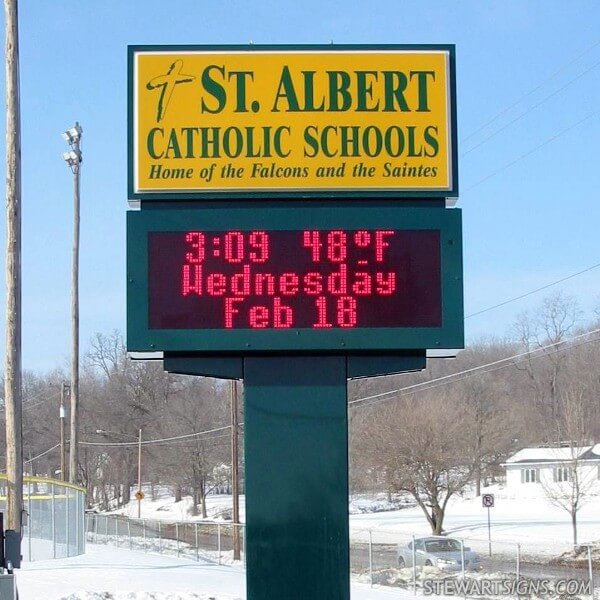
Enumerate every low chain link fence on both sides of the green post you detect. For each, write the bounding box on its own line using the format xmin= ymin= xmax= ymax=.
xmin=86 ymin=514 xmax=600 ymax=600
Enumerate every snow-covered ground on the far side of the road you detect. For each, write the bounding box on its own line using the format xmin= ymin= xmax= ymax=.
xmin=113 ymin=486 xmax=600 ymax=558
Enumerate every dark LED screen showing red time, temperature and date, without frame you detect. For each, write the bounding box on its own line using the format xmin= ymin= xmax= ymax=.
xmin=148 ymin=229 xmax=442 ymax=330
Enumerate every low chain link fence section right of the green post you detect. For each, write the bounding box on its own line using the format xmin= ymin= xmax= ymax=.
xmin=350 ymin=529 xmax=600 ymax=600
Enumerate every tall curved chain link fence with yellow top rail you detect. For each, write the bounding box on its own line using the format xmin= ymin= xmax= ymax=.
xmin=0 ymin=474 xmax=85 ymax=561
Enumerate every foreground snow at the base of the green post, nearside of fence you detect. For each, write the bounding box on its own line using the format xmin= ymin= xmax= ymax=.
xmin=17 ymin=544 xmax=426 ymax=600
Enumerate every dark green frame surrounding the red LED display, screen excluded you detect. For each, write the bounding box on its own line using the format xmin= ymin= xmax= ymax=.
xmin=127 ymin=203 xmax=464 ymax=355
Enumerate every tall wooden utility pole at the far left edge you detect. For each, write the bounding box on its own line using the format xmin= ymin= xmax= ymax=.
xmin=4 ymin=0 xmax=23 ymax=533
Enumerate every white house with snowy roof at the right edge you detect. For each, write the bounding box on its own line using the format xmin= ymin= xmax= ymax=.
xmin=503 ymin=444 xmax=600 ymax=497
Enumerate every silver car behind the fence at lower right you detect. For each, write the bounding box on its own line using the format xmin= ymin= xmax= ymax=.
xmin=397 ymin=535 xmax=480 ymax=571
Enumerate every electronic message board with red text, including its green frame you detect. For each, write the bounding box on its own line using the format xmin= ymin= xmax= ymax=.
xmin=128 ymin=207 xmax=462 ymax=352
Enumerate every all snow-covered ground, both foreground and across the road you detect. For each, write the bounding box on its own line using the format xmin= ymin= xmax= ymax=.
xmin=17 ymin=488 xmax=600 ymax=600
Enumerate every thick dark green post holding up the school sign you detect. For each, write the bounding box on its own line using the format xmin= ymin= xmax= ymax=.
xmin=244 ymin=356 xmax=350 ymax=600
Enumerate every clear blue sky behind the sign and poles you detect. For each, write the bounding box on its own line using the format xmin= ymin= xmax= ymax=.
xmin=0 ymin=0 xmax=600 ymax=371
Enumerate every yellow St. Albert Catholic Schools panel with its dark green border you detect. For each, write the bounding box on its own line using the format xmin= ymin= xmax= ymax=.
xmin=129 ymin=46 xmax=457 ymax=199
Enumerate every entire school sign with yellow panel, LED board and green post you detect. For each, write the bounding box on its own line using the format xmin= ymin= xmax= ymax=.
xmin=127 ymin=46 xmax=463 ymax=600
